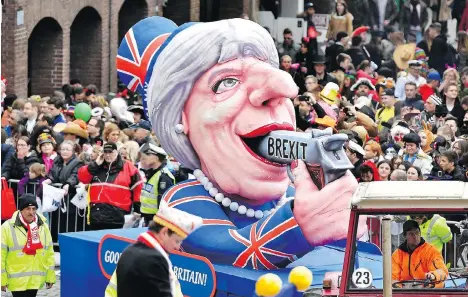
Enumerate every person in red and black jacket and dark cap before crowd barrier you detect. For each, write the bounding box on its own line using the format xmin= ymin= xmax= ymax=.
xmin=78 ymin=142 xmax=143 ymax=230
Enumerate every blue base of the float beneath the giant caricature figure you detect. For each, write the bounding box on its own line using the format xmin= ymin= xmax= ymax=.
xmin=59 ymin=228 xmax=382 ymax=297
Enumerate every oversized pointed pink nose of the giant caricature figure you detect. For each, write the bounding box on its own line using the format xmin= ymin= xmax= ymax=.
xmin=249 ymin=66 xmax=298 ymax=106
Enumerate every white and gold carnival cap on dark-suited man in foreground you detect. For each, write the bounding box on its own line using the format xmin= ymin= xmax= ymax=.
xmin=153 ymin=201 xmax=203 ymax=239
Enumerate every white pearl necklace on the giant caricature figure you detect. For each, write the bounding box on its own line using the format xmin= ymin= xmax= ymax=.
xmin=193 ymin=169 xmax=292 ymax=219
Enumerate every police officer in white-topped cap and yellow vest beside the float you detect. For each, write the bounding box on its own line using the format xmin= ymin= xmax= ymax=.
xmin=140 ymin=142 xmax=175 ymax=226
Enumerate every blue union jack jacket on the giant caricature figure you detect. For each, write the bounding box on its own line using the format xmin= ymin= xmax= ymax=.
xmin=163 ymin=180 xmax=312 ymax=269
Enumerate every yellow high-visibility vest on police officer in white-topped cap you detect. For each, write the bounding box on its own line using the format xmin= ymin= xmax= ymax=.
xmin=140 ymin=168 xmax=175 ymax=214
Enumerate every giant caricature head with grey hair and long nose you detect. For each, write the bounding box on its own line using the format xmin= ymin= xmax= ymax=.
xmin=147 ymin=19 xmax=298 ymax=202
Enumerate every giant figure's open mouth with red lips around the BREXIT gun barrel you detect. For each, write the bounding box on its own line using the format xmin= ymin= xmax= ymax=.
xmin=240 ymin=122 xmax=294 ymax=167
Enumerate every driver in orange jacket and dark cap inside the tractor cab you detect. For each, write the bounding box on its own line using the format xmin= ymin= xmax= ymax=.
xmin=392 ymin=220 xmax=448 ymax=288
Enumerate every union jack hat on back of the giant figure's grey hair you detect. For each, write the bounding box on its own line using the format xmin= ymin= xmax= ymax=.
xmin=116 ymin=16 xmax=178 ymax=116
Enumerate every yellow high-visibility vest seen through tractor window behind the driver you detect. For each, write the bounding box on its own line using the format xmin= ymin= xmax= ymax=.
xmin=419 ymin=214 xmax=453 ymax=252
